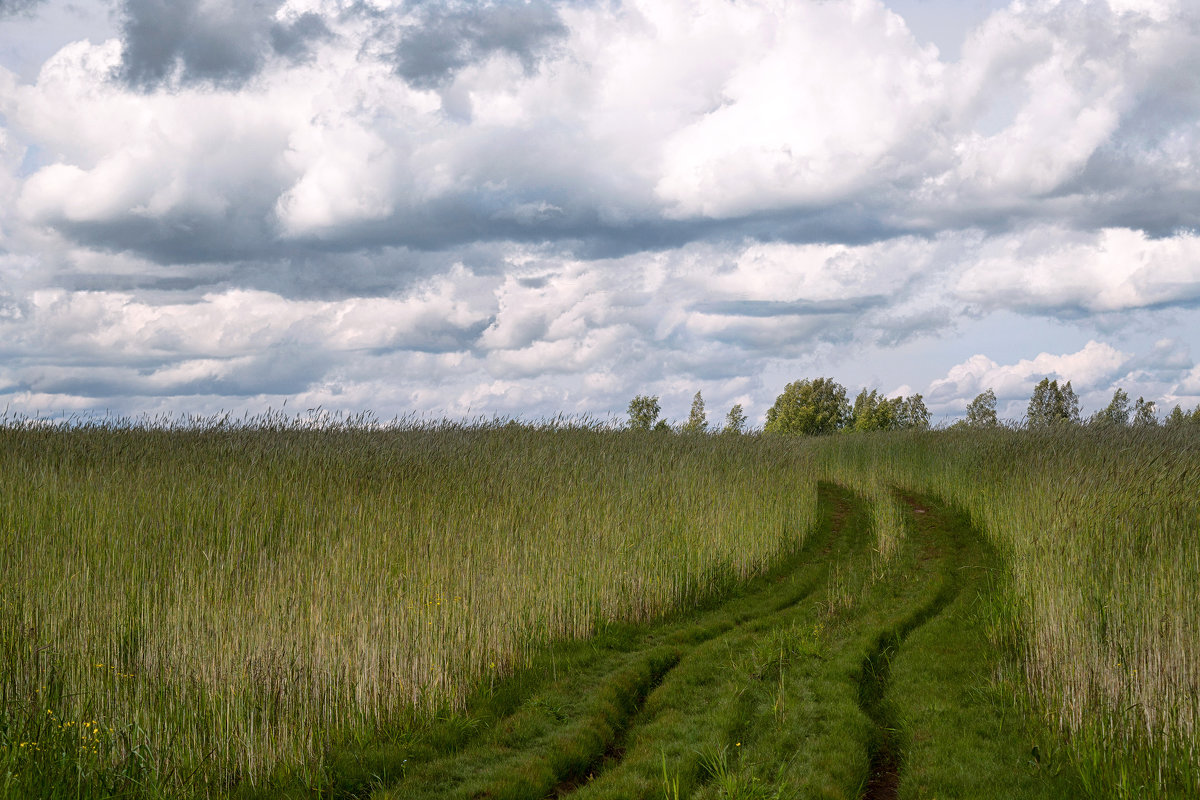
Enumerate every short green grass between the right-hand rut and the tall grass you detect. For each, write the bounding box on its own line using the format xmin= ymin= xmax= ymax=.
xmin=888 ymin=497 xmax=1080 ymax=800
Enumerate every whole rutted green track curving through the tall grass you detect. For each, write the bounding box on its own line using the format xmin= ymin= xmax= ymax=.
xmin=300 ymin=485 xmax=1062 ymax=800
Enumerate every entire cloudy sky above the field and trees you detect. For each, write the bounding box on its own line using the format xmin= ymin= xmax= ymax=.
xmin=0 ymin=0 xmax=1200 ymax=425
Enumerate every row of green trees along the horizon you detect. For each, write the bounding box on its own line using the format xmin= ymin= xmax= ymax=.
xmin=628 ymin=378 xmax=1200 ymax=435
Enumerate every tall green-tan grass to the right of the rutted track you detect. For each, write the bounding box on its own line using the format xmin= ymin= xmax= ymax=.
xmin=811 ymin=427 xmax=1200 ymax=796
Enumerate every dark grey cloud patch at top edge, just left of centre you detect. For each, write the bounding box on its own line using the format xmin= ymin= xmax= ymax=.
xmin=392 ymin=0 xmax=568 ymax=89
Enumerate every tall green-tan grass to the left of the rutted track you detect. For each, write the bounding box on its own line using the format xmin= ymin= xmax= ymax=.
xmin=0 ymin=417 xmax=815 ymax=793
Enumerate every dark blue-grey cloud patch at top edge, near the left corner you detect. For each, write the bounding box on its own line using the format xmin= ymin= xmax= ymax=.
xmin=120 ymin=0 xmax=331 ymax=89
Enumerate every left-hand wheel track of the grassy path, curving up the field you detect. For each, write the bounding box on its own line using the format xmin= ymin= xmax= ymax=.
xmin=355 ymin=485 xmax=868 ymax=800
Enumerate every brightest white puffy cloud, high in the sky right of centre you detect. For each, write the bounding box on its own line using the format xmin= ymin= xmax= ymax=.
xmin=655 ymin=4 xmax=944 ymax=218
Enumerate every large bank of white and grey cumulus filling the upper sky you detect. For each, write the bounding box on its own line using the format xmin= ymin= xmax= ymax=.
xmin=4 ymin=0 xmax=1200 ymax=263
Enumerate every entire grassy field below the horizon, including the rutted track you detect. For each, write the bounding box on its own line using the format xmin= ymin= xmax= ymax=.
xmin=0 ymin=417 xmax=1200 ymax=799
